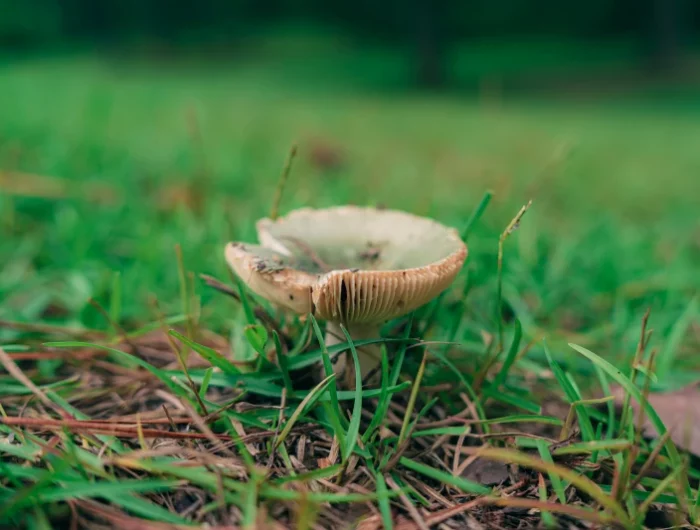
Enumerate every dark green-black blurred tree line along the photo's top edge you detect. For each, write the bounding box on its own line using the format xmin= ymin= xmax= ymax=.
xmin=0 ymin=0 xmax=700 ymax=88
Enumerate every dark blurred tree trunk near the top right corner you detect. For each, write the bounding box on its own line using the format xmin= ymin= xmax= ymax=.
xmin=647 ymin=0 xmax=682 ymax=71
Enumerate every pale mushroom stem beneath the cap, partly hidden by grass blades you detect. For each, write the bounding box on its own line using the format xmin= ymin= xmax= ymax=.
xmin=325 ymin=321 xmax=381 ymax=388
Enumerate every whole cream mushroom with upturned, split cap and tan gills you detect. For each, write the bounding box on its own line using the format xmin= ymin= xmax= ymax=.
xmin=226 ymin=206 xmax=467 ymax=386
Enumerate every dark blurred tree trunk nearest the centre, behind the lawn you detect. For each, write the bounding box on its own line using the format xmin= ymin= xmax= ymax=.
xmin=415 ymin=0 xmax=448 ymax=88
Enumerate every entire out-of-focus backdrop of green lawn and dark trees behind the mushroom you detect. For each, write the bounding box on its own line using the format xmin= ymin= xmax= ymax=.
xmin=0 ymin=0 xmax=700 ymax=366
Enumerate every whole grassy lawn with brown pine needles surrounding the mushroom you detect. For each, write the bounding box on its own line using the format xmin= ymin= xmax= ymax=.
xmin=0 ymin=47 xmax=700 ymax=529
